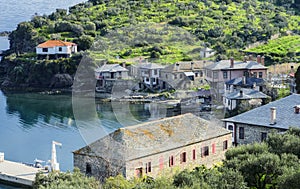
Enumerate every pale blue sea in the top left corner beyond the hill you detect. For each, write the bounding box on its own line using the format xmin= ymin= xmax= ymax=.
xmin=0 ymin=0 xmax=86 ymax=32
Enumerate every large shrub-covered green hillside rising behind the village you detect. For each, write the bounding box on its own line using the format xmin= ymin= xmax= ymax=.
xmin=6 ymin=0 xmax=300 ymax=62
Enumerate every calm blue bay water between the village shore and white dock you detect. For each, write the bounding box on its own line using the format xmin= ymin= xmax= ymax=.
xmin=0 ymin=91 xmax=166 ymax=189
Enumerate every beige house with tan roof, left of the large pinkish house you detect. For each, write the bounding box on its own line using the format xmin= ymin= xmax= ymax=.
xmin=160 ymin=61 xmax=211 ymax=90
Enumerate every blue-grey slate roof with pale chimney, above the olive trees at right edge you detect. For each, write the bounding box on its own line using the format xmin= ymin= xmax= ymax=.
xmin=223 ymin=94 xmax=300 ymax=129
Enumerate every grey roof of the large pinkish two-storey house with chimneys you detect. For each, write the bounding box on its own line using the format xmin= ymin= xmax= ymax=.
xmin=206 ymin=60 xmax=267 ymax=70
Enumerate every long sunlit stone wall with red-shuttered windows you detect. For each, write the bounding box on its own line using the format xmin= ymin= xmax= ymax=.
xmin=126 ymin=133 xmax=232 ymax=179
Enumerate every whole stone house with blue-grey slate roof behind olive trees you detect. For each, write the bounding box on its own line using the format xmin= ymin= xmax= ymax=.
xmin=223 ymin=94 xmax=300 ymax=145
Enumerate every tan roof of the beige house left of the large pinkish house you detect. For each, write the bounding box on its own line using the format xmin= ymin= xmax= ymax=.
xmin=162 ymin=60 xmax=212 ymax=72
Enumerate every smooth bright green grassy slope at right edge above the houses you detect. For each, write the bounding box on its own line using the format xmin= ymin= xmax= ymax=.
xmin=245 ymin=35 xmax=300 ymax=63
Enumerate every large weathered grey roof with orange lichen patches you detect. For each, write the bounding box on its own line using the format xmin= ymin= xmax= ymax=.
xmin=74 ymin=113 xmax=230 ymax=160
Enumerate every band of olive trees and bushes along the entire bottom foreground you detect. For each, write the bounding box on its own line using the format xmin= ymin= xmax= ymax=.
xmin=35 ymin=128 xmax=300 ymax=189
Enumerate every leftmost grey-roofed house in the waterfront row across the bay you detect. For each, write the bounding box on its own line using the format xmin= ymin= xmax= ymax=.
xmin=95 ymin=63 xmax=129 ymax=93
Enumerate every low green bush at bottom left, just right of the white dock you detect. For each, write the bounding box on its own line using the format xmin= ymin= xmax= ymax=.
xmin=33 ymin=168 xmax=100 ymax=189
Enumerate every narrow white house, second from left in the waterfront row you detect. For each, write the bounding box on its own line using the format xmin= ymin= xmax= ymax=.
xmin=130 ymin=63 xmax=164 ymax=91
